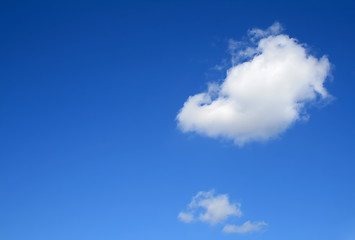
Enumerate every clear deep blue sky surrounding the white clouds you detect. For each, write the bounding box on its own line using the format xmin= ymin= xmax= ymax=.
xmin=0 ymin=1 xmax=355 ymax=240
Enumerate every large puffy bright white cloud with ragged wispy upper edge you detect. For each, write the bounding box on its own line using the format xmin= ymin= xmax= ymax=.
xmin=177 ymin=23 xmax=330 ymax=145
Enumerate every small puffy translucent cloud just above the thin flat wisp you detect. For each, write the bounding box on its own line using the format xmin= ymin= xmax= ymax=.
xmin=178 ymin=191 xmax=242 ymax=225
